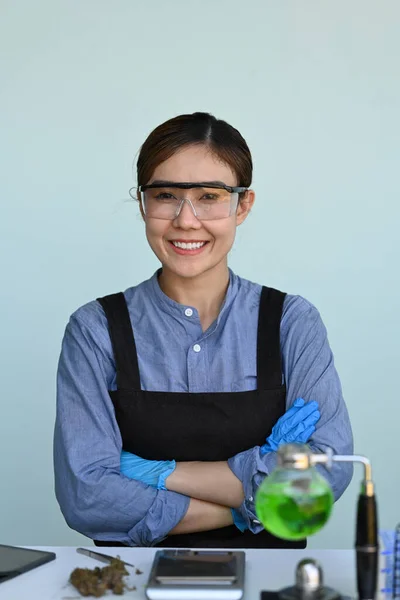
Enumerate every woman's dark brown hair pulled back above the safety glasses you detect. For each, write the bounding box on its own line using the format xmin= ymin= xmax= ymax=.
xmin=137 ymin=112 xmax=253 ymax=187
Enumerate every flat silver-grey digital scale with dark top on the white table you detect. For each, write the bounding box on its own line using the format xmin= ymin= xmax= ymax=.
xmin=146 ymin=550 xmax=245 ymax=600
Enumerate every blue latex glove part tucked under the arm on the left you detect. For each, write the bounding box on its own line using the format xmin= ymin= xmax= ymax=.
xmin=120 ymin=450 xmax=176 ymax=490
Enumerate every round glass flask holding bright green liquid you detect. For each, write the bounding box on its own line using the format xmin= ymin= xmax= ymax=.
xmin=256 ymin=469 xmax=334 ymax=541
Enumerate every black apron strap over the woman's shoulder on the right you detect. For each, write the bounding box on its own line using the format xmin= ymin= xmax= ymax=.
xmin=257 ymin=286 xmax=286 ymax=390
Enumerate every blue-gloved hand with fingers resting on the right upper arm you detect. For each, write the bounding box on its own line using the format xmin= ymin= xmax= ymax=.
xmin=260 ymin=398 xmax=321 ymax=456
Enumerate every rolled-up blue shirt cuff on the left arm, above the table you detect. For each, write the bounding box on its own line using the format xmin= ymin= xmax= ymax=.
xmin=128 ymin=490 xmax=190 ymax=546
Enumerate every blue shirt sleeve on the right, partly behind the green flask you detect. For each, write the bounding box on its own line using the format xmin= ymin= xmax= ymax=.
xmin=228 ymin=296 xmax=353 ymax=533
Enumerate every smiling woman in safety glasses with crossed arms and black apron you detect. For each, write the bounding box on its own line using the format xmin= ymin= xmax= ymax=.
xmin=54 ymin=113 xmax=353 ymax=548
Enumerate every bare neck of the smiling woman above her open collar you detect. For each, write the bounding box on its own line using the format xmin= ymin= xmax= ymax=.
xmin=159 ymin=261 xmax=229 ymax=331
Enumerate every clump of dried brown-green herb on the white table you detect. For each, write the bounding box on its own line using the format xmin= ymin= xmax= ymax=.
xmin=69 ymin=558 xmax=129 ymax=598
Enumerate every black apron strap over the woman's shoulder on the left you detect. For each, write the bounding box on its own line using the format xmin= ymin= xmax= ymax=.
xmin=97 ymin=292 xmax=141 ymax=391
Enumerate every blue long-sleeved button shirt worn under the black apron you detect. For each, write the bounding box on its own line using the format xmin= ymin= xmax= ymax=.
xmin=54 ymin=272 xmax=353 ymax=546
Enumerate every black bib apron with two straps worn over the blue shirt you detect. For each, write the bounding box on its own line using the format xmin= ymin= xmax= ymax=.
xmin=94 ymin=287 xmax=306 ymax=548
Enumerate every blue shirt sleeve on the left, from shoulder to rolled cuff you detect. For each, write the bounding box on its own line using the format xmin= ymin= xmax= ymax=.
xmin=54 ymin=311 xmax=190 ymax=546
